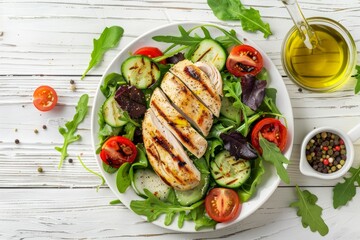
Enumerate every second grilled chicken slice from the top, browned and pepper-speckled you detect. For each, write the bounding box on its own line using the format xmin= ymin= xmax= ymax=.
xmin=160 ymin=72 xmax=213 ymax=136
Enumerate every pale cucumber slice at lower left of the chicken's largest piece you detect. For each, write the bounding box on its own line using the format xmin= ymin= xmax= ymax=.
xmin=132 ymin=168 xmax=171 ymax=200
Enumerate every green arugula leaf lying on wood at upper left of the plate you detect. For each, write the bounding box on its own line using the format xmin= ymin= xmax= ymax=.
xmin=81 ymin=26 xmax=124 ymax=79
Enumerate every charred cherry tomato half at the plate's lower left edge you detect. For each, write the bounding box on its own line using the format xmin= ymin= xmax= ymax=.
xmin=100 ymin=136 xmax=137 ymax=168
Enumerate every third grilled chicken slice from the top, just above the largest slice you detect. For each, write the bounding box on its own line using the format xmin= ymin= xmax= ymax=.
xmin=150 ymin=88 xmax=207 ymax=158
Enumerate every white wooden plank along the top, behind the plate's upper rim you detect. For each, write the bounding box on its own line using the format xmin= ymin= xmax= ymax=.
xmin=0 ymin=0 xmax=360 ymax=76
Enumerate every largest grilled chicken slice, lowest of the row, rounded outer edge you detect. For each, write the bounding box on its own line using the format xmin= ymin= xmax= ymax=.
xmin=142 ymin=108 xmax=200 ymax=191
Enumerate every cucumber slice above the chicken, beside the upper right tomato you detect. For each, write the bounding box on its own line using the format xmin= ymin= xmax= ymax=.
xmin=191 ymin=39 xmax=226 ymax=71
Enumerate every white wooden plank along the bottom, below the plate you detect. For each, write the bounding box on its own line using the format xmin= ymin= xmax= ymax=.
xmin=0 ymin=188 xmax=360 ymax=240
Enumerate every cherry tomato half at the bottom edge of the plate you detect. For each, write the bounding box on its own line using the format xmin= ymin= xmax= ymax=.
xmin=205 ymin=188 xmax=242 ymax=222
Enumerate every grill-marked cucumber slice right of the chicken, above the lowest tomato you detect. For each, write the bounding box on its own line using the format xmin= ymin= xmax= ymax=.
xmin=210 ymin=150 xmax=251 ymax=188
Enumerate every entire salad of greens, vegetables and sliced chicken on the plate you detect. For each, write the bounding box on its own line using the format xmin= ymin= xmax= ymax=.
xmin=92 ymin=24 xmax=291 ymax=230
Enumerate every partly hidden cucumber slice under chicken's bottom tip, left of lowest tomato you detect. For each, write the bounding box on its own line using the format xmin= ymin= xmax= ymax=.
xmin=175 ymin=170 xmax=210 ymax=206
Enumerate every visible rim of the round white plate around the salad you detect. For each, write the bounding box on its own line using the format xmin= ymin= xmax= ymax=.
xmin=91 ymin=23 xmax=294 ymax=232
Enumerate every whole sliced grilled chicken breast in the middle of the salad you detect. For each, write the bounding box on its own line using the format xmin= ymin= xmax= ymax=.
xmin=142 ymin=60 xmax=222 ymax=191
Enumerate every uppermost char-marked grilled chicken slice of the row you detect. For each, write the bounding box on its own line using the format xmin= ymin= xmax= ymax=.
xmin=170 ymin=59 xmax=221 ymax=117
